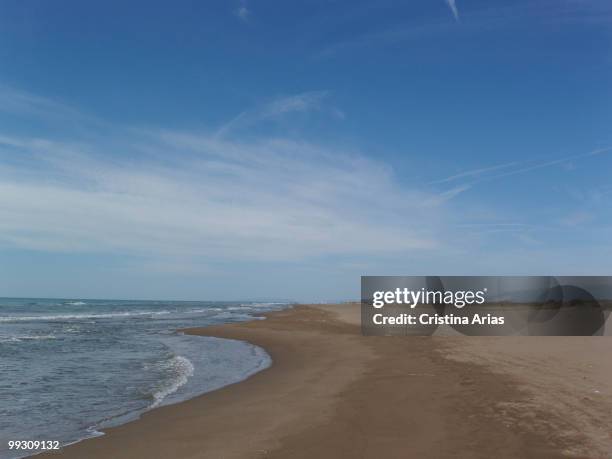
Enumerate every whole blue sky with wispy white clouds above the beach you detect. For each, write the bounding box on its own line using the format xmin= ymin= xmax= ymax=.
xmin=0 ymin=0 xmax=612 ymax=301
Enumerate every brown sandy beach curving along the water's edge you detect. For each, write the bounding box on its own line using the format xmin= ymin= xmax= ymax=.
xmin=41 ymin=305 xmax=612 ymax=459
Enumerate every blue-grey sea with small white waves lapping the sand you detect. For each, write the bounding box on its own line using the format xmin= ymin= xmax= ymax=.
xmin=0 ymin=298 xmax=288 ymax=459
